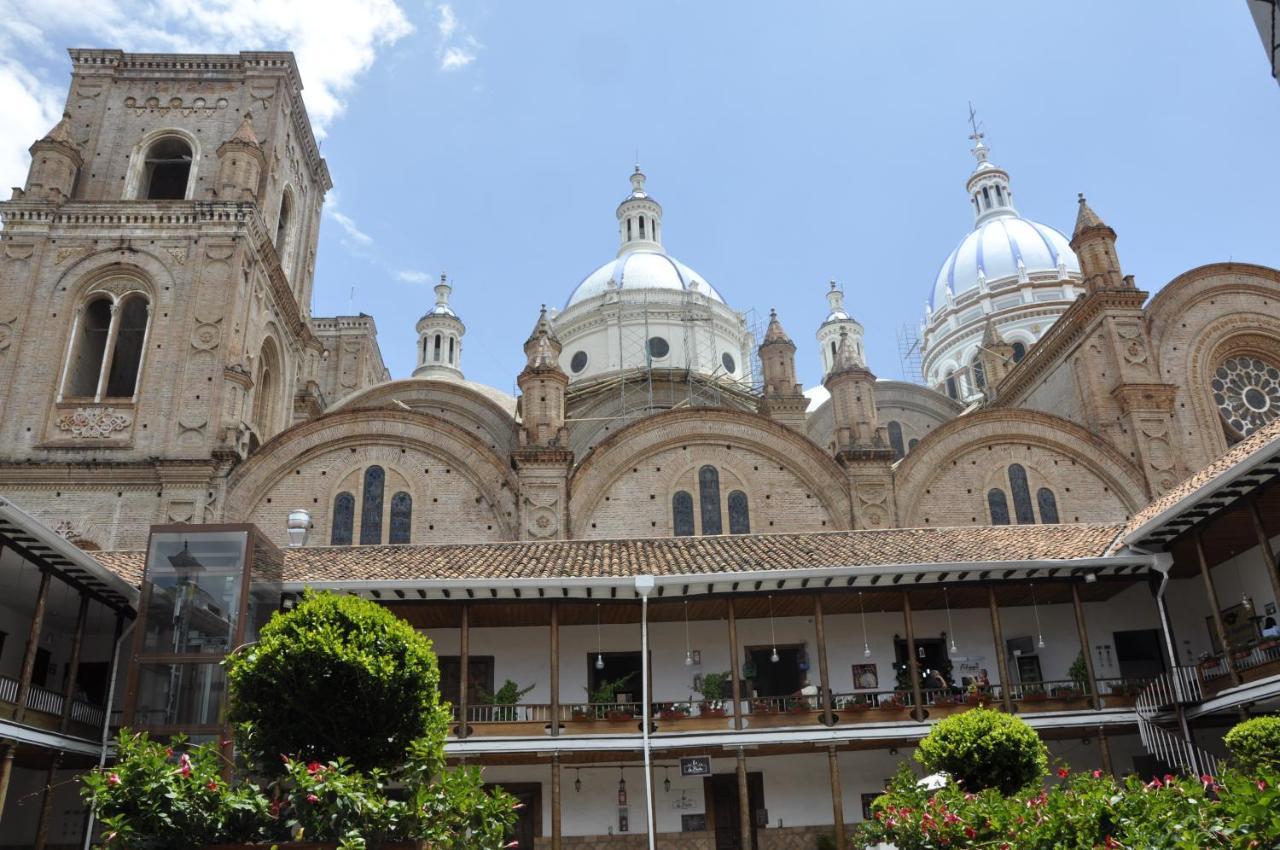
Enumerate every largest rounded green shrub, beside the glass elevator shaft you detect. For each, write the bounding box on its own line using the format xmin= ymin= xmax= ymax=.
xmin=227 ymin=593 xmax=448 ymax=773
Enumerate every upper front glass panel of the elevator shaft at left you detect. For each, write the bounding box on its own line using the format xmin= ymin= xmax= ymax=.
xmin=143 ymin=531 xmax=248 ymax=654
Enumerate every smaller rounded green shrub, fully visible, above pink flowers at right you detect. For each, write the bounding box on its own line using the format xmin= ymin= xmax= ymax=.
xmin=915 ymin=708 xmax=1048 ymax=794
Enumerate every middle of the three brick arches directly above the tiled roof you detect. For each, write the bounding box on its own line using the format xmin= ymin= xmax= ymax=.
xmin=570 ymin=408 xmax=851 ymax=536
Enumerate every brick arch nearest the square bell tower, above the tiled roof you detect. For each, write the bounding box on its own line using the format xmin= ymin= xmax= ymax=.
xmin=225 ymin=410 xmax=518 ymax=540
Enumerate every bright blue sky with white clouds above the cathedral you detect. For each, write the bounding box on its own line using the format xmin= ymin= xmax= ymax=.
xmin=0 ymin=0 xmax=1280 ymax=392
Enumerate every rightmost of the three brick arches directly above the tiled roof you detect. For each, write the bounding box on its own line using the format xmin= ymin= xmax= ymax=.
xmin=893 ymin=410 xmax=1149 ymax=526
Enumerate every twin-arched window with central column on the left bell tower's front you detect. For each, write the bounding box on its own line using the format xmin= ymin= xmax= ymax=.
xmin=59 ymin=291 xmax=150 ymax=401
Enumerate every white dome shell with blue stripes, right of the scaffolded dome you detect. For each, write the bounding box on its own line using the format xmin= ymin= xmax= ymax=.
xmin=931 ymin=215 xmax=1080 ymax=310
